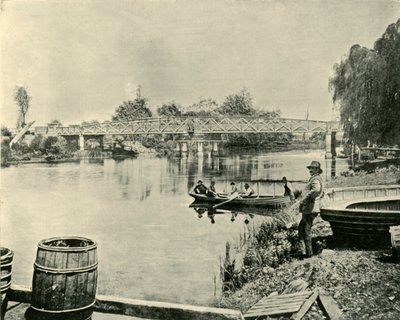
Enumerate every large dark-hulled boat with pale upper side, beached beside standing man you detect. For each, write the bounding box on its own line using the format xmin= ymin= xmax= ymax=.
xmin=321 ymin=185 xmax=400 ymax=239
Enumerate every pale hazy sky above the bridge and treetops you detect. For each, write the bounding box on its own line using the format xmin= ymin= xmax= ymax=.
xmin=0 ymin=0 xmax=400 ymax=128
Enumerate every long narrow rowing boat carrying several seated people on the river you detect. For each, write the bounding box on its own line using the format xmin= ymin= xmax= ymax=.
xmin=189 ymin=192 xmax=291 ymax=209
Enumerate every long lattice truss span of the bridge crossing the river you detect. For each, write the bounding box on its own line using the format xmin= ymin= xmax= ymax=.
xmin=39 ymin=117 xmax=341 ymax=136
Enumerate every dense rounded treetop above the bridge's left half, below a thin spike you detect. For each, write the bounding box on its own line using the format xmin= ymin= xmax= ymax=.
xmin=112 ymin=97 xmax=152 ymax=121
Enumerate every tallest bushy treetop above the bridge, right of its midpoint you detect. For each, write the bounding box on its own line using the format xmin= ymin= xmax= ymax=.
xmin=218 ymin=88 xmax=256 ymax=116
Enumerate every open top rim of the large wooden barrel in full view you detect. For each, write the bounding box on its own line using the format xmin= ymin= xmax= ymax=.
xmin=38 ymin=236 xmax=97 ymax=251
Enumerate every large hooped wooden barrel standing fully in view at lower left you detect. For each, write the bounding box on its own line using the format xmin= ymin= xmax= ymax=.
xmin=31 ymin=237 xmax=97 ymax=313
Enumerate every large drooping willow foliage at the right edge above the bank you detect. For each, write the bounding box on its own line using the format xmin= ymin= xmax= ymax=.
xmin=329 ymin=19 xmax=400 ymax=145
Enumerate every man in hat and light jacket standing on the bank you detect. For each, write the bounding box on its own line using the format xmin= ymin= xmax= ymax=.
xmin=299 ymin=161 xmax=324 ymax=258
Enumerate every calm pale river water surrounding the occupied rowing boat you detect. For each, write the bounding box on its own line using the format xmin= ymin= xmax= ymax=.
xmin=0 ymin=151 xmax=346 ymax=305
